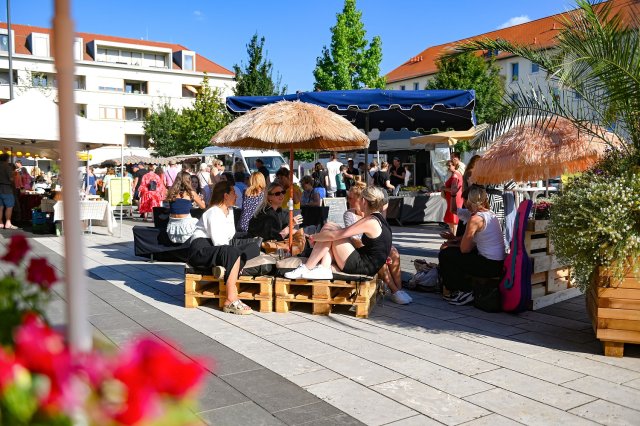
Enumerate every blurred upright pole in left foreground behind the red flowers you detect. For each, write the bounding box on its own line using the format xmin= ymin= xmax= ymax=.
xmin=53 ymin=0 xmax=91 ymax=352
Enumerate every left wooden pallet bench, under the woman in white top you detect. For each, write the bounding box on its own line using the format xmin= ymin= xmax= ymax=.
xmin=184 ymin=273 xmax=274 ymax=312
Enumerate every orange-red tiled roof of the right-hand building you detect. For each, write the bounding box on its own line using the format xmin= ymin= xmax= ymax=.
xmin=386 ymin=0 xmax=640 ymax=83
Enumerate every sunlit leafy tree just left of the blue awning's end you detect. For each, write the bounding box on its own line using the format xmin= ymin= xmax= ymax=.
xmin=179 ymin=74 xmax=231 ymax=154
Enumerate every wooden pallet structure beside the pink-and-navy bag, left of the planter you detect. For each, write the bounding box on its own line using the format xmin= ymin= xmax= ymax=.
xmin=525 ymin=219 xmax=580 ymax=310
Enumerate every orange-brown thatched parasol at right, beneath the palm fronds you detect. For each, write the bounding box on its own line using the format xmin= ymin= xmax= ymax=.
xmin=471 ymin=118 xmax=622 ymax=184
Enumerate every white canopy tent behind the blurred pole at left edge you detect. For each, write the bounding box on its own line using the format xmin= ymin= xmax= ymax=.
xmin=0 ymin=90 xmax=123 ymax=160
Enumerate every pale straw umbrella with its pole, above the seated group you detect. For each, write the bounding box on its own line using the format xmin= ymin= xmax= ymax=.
xmin=211 ymin=101 xmax=369 ymax=249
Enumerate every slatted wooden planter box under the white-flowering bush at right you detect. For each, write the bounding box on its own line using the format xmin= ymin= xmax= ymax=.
xmin=587 ymin=259 xmax=640 ymax=357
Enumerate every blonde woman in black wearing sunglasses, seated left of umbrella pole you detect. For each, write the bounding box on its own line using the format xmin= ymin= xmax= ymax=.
xmin=247 ymin=182 xmax=302 ymax=241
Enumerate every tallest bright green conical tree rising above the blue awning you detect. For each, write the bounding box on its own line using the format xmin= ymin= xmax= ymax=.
xmin=313 ymin=0 xmax=385 ymax=90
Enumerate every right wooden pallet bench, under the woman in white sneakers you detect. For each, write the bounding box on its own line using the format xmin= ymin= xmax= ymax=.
xmin=275 ymin=278 xmax=376 ymax=318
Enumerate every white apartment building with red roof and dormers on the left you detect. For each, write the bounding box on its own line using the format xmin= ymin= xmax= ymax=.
xmin=0 ymin=23 xmax=235 ymax=163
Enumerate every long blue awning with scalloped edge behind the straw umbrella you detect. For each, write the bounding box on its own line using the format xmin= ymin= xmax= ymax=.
xmin=227 ymin=89 xmax=475 ymax=133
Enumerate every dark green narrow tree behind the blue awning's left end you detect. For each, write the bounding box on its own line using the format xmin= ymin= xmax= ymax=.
xmin=233 ymin=33 xmax=287 ymax=96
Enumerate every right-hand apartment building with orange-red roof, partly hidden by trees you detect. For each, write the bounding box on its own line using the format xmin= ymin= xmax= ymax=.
xmin=386 ymin=0 xmax=640 ymax=108
